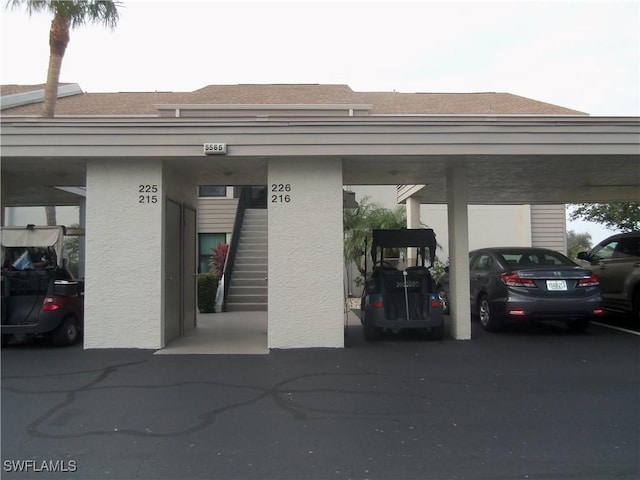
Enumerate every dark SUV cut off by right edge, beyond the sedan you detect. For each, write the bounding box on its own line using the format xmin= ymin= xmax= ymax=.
xmin=577 ymin=232 xmax=640 ymax=322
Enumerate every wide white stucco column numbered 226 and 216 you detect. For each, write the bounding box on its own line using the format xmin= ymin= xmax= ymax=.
xmin=268 ymin=158 xmax=344 ymax=348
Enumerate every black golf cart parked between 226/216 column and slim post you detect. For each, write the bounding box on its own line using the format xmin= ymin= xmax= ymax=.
xmin=360 ymin=229 xmax=444 ymax=340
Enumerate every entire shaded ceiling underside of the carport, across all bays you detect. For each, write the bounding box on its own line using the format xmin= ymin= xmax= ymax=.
xmin=2 ymin=155 xmax=640 ymax=206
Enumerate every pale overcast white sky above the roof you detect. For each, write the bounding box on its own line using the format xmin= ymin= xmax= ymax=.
xmin=0 ymin=0 xmax=640 ymax=244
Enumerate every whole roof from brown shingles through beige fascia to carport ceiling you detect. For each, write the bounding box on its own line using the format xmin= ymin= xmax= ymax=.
xmin=0 ymin=84 xmax=640 ymax=210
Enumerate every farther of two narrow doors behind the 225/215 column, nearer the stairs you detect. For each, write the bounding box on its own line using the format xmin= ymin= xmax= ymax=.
xmin=182 ymin=206 xmax=197 ymax=335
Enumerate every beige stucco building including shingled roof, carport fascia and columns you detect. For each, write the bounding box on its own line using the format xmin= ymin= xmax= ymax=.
xmin=0 ymin=85 xmax=640 ymax=349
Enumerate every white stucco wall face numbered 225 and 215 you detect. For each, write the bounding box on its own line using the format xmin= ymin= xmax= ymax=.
xmin=84 ymin=160 xmax=164 ymax=348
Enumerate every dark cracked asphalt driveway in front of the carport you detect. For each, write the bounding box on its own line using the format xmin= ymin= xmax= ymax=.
xmin=1 ymin=318 xmax=640 ymax=479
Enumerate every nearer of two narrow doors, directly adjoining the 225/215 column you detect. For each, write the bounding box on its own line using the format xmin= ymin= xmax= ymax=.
xmin=164 ymin=199 xmax=182 ymax=345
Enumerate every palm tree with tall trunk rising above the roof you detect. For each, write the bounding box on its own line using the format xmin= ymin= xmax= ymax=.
xmin=6 ymin=0 xmax=121 ymax=118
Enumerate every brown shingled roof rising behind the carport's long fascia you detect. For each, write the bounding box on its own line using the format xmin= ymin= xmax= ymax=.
xmin=0 ymin=84 xmax=587 ymax=116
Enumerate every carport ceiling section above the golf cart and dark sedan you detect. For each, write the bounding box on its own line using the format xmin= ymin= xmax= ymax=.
xmin=343 ymin=155 xmax=640 ymax=205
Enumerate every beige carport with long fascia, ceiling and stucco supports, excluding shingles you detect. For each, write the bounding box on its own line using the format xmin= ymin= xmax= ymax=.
xmin=1 ymin=116 xmax=640 ymax=348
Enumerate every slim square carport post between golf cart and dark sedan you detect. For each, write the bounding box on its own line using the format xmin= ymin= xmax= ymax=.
xmin=447 ymin=167 xmax=471 ymax=340
